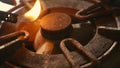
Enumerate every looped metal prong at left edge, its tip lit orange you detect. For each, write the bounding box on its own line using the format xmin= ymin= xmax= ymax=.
xmin=0 ymin=31 xmax=29 ymax=50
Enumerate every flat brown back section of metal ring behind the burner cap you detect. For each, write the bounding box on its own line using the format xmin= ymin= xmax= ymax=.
xmin=41 ymin=0 xmax=93 ymax=10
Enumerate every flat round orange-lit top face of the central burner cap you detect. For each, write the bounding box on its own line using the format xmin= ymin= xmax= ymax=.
xmin=41 ymin=13 xmax=71 ymax=31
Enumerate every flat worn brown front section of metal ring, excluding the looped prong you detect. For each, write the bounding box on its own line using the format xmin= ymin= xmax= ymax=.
xmin=10 ymin=7 xmax=117 ymax=68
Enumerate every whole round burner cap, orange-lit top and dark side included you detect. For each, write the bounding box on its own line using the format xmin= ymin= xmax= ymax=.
xmin=41 ymin=12 xmax=72 ymax=40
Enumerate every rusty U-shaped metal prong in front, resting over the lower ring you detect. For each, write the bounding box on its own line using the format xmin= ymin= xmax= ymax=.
xmin=60 ymin=38 xmax=97 ymax=68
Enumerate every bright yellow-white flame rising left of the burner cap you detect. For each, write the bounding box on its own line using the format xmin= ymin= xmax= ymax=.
xmin=24 ymin=0 xmax=41 ymax=22
